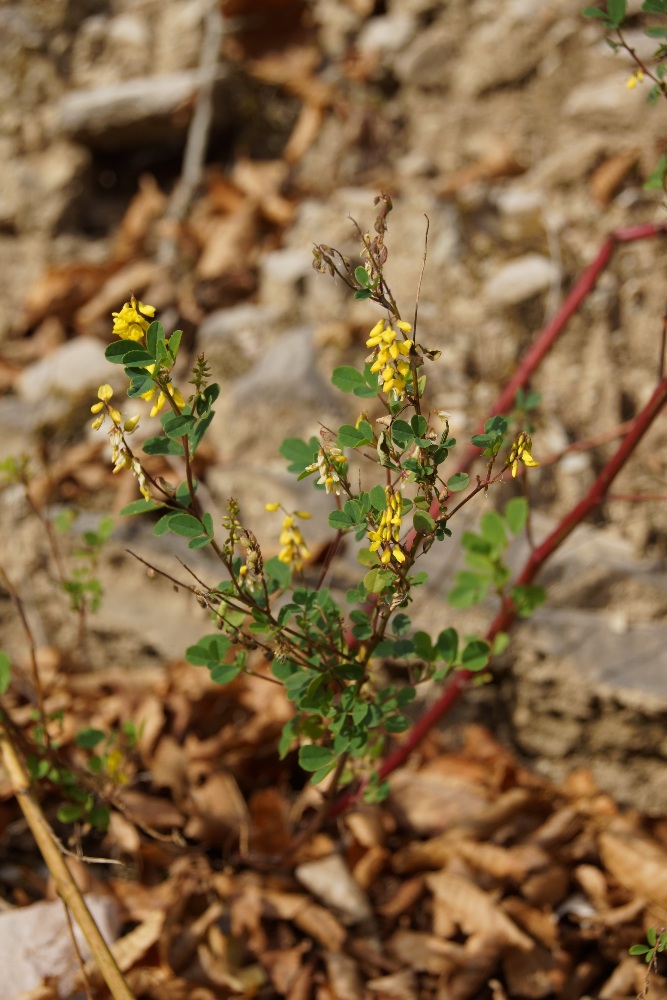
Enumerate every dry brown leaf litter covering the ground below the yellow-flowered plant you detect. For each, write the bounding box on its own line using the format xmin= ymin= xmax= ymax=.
xmin=0 ymin=662 xmax=667 ymax=1000
